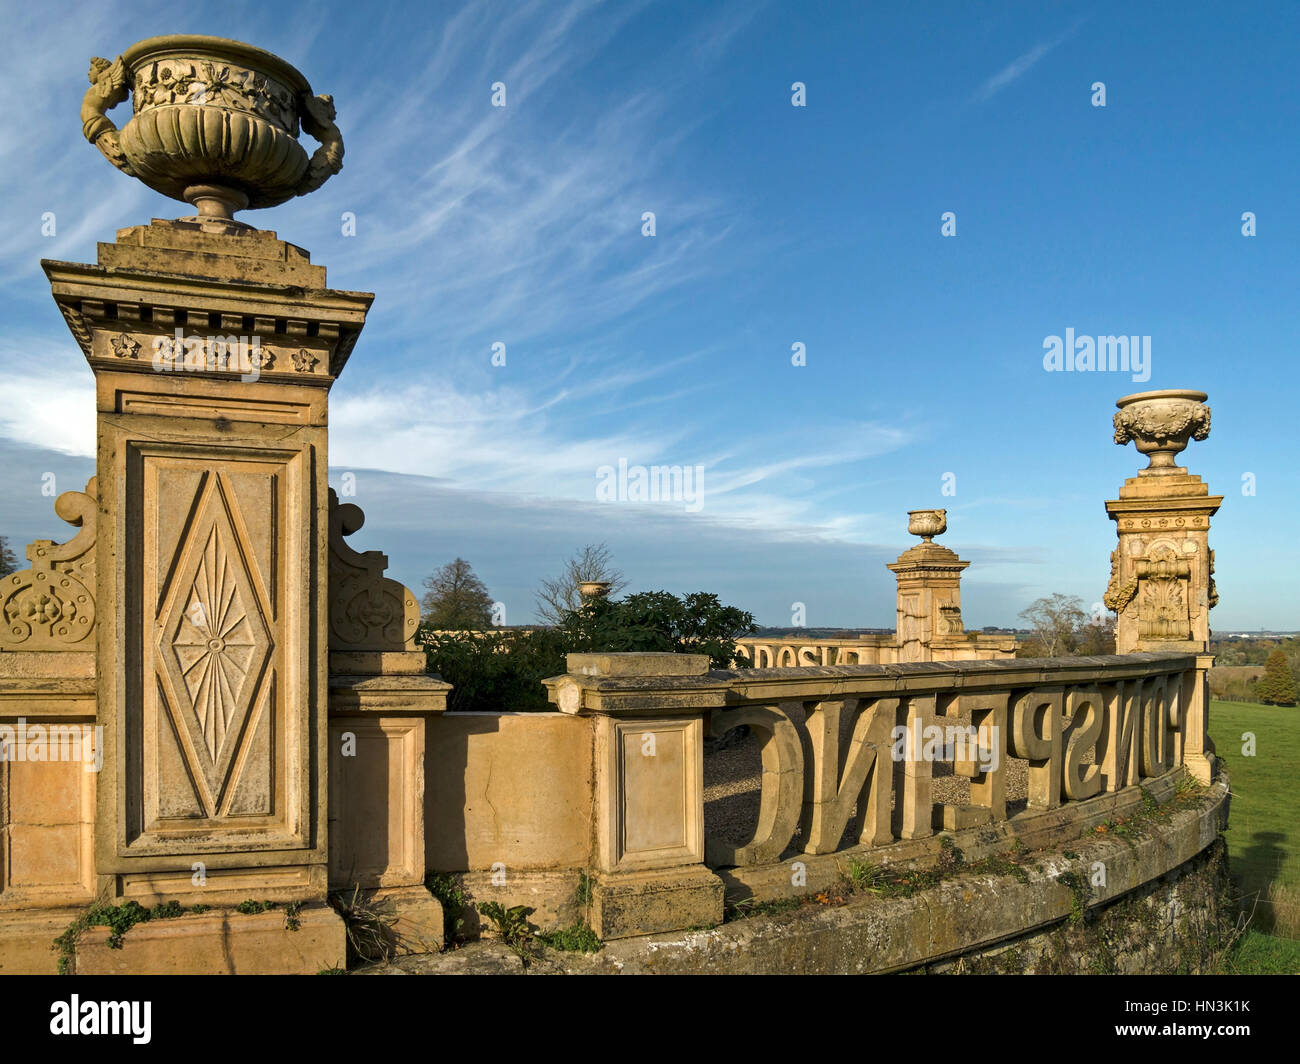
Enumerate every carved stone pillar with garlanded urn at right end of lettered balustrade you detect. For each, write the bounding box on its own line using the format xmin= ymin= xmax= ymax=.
xmin=1104 ymin=390 xmax=1223 ymax=782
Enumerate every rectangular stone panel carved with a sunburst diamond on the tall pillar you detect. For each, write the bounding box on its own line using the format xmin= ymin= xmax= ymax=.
xmin=126 ymin=445 xmax=311 ymax=853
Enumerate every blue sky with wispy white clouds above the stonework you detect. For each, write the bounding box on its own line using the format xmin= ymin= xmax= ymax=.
xmin=0 ymin=0 xmax=1300 ymax=630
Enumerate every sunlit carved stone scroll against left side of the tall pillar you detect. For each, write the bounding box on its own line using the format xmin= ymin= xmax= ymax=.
xmin=0 ymin=477 xmax=98 ymax=650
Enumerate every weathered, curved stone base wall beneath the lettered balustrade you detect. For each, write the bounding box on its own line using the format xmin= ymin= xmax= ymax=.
xmin=377 ymin=780 xmax=1235 ymax=974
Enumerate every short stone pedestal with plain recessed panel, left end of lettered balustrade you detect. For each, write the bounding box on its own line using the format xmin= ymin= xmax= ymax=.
xmin=545 ymin=653 xmax=727 ymax=938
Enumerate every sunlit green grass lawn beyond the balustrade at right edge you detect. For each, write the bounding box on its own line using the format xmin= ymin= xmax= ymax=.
xmin=1210 ymin=701 xmax=1300 ymax=974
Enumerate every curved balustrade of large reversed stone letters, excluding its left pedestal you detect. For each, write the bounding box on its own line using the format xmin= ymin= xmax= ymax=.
xmin=706 ymin=642 xmax=1210 ymax=868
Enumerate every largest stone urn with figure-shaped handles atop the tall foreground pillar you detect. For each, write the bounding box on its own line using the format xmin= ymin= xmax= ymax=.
xmin=82 ymin=35 xmax=343 ymax=232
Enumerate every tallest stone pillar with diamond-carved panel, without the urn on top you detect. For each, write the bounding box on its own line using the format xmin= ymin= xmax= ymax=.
xmin=43 ymin=220 xmax=373 ymax=952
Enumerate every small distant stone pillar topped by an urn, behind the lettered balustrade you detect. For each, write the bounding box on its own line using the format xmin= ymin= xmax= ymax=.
xmin=888 ymin=510 xmax=970 ymax=661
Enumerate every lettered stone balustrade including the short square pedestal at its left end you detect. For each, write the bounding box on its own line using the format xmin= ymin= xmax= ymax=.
xmin=533 ymin=652 xmax=1214 ymax=937
